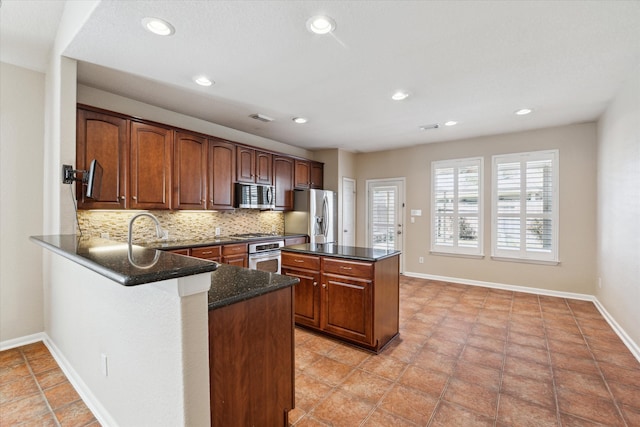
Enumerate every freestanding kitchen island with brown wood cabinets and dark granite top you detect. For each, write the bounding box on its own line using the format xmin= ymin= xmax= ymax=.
xmin=282 ymin=244 xmax=400 ymax=353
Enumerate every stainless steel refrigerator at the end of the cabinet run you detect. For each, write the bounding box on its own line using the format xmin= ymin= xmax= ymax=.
xmin=284 ymin=189 xmax=338 ymax=244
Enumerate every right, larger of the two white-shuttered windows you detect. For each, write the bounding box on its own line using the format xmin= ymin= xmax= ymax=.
xmin=492 ymin=150 xmax=558 ymax=262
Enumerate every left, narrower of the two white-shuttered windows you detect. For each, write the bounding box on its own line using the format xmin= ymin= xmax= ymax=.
xmin=431 ymin=158 xmax=483 ymax=255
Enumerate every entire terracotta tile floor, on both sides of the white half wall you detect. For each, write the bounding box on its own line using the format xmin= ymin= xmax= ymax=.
xmin=0 ymin=277 xmax=640 ymax=427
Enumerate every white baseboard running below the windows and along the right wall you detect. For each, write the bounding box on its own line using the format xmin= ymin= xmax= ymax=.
xmin=403 ymin=271 xmax=640 ymax=362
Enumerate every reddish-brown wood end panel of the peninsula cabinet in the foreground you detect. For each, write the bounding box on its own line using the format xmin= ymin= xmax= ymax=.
xmin=209 ymin=287 xmax=294 ymax=427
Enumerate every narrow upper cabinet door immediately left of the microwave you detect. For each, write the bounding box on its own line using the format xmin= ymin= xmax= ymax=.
xmin=208 ymin=139 xmax=236 ymax=209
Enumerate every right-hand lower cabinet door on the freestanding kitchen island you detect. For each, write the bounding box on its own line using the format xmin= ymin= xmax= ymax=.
xmin=321 ymin=274 xmax=373 ymax=345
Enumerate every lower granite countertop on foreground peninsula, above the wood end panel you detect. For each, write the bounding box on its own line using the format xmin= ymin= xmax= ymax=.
xmin=209 ymin=264 xmax=300 ymax=310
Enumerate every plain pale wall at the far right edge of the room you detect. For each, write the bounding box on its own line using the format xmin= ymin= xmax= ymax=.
xmin=596 ymin=69 xmax=640 ymax=346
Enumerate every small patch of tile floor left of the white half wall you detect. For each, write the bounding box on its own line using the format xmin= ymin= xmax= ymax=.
xmin=0 ymin=342 xmax=100 ymax=427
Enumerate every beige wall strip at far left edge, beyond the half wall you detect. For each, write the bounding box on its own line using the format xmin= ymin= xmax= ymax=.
xmin=0 ymin=63 xmax=45 ymax=342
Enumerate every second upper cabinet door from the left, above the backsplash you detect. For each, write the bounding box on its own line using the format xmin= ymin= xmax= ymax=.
xmin=129 ymin=122 xmax=173 ymax=209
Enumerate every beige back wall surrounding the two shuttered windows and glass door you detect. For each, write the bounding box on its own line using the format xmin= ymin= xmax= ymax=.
xmin=356 ymin=123 xmax=596 ymax=294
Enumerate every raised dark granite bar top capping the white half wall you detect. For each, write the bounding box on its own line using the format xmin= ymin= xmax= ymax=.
xmin=30 ymin=234 xmax=219 ymax=286
